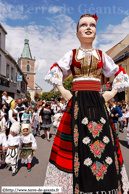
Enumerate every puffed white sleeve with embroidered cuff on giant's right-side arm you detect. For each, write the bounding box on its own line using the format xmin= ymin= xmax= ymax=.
xmin=102 ymin=52 xmax=129 ymax=92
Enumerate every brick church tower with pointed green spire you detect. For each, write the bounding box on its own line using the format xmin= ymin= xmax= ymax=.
xmin=18 ymin=33 xmax=37 ymax=100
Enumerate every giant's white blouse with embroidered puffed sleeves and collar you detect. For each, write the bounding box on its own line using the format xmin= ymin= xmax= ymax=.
xmin=45 ymin=49 xmax=129 ymax=92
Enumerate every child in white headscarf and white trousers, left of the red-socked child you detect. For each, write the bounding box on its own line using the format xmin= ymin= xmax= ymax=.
xmin=5 ymin=121 xmax=21 ymax=176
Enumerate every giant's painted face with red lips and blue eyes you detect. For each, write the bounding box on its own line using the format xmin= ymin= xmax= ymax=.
xmin=77 ymin=17 xmax=96 ymax=43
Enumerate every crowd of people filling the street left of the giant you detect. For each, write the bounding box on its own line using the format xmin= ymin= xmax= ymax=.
xmin=0 ymin=92 xmax=66 ymax=176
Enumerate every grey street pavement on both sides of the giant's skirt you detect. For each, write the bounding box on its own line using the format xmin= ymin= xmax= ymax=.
xmin=0 ymin=128 xmax=129 ymax=192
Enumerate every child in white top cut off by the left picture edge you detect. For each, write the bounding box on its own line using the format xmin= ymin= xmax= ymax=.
xmin=0 ymin=121 xmax=8 ymax=168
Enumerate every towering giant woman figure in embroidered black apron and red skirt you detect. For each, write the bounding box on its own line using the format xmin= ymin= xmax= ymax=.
xmin=44 ymin=14 xmax=129 ymax=194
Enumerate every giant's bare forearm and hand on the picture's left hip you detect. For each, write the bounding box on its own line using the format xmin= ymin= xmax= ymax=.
xmin=56 ymin=85 xmax=72 ymax=101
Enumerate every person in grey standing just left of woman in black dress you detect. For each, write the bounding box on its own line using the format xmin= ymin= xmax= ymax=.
xmin=32 ymin=107 xmax=40 ymax=135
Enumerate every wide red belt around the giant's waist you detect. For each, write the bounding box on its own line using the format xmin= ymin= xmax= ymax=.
xmin=73 ymin=80 xmax=101 ymax=92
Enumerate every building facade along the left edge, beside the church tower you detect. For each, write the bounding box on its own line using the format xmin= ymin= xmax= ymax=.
xmin=0 ymin=24 xmax=27 ymax=99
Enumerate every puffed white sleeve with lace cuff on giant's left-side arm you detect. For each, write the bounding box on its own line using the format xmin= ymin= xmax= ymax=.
xmin=45 ymin=50 xmax=73 ymax=85
